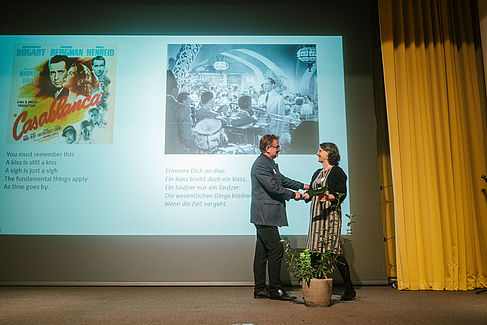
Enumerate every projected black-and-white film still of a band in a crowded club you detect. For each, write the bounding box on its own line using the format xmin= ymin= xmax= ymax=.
xmin=165 ymin=44 xmax=319 ymax=154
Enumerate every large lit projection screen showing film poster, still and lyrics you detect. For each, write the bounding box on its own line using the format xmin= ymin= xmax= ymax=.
xmin=0 ymin=35 xmax=350 ymax=236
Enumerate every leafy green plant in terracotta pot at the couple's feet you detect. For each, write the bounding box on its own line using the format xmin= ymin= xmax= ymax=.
xmin=282 ymin=206 xmax=353 ymax=307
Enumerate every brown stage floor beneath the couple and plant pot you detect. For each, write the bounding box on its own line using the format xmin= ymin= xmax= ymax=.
xmin=0 ymin=286 xmax=487 ymax=325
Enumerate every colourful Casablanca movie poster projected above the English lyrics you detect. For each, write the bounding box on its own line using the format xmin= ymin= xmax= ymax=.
xmin=6 ymin=43 xmax=117 ymax=144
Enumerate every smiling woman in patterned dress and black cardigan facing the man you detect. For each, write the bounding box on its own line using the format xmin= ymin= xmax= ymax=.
xmin=303 ymin=142 xmax=356 ymax=300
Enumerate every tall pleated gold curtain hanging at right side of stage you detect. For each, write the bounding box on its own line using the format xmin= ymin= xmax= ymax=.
xmin=379 ymin=0 xmax=487 ymax=290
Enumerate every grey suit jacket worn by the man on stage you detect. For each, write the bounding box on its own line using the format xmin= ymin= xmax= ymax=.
xmin=254 ymin=154 xmax=304 ymax=226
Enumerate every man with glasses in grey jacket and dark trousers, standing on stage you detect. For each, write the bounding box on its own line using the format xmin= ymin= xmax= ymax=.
xmin=250 ymin=134 xmax=309 ymax=300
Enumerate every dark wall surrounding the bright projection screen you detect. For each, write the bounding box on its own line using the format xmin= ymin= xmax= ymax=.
xmin=0 ymin=0 xmax=386 ymax=284
